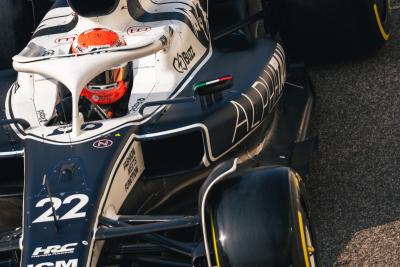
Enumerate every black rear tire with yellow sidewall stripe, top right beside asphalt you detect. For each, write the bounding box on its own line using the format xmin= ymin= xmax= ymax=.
xmin=272 ymin=0 xmax=390 ymax=61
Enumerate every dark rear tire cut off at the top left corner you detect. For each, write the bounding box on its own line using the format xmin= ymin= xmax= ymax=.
xmin=0 ymin=0 xmax=33 ymax=69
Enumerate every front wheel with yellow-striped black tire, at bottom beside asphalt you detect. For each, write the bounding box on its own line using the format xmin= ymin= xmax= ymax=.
xmin=200 ymin=167 xmax=318 ymax=267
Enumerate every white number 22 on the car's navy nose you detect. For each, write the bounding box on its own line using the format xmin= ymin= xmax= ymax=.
xmin=33 ymin=194 xmax=89 ymax=223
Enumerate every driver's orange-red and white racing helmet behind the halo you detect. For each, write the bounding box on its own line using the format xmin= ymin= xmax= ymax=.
xmin=71 ymin=28 xmax=130 ymax=105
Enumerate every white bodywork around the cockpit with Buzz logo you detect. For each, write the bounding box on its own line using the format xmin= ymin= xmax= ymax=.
xmin=6 ymin=0 xmax=212 ymax=144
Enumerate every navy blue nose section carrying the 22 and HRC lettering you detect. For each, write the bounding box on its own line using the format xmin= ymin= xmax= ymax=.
xmin=22 ymin=126 xmax=127 ymax=266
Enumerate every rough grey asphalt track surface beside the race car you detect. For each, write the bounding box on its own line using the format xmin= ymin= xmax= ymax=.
xmin=0 ymin=4 xmax=400 ymax=266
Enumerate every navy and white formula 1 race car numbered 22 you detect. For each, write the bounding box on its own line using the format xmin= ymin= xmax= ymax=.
xmin=0 ymin=0 xmax=390 ymax=267
